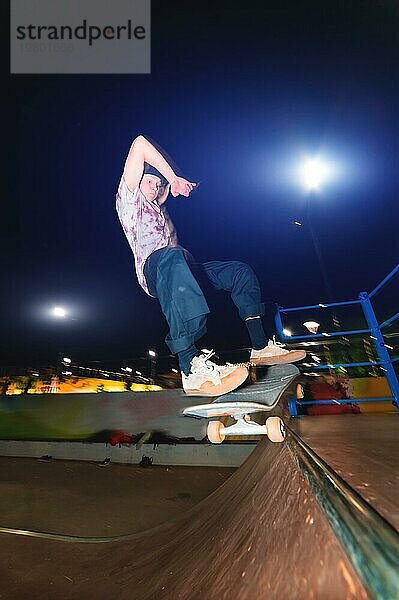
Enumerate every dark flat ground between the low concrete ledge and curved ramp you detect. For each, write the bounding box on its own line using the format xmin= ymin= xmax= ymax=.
xmin=0 ymin=457 xmax=238 ymax=537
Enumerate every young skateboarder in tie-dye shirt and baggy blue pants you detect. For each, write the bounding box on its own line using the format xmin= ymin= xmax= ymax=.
xmin=116 ymin=135 xmax=305 ymax=396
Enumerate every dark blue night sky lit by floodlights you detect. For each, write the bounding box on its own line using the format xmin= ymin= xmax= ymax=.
xmin=0 ymin=0 xmax=399 ymax=366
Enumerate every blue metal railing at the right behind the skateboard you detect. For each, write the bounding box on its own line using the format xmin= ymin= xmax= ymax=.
xmin=274 ymin=265 xmax=399 ymax=416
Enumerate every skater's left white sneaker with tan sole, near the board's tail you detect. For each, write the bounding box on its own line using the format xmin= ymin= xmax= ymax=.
xmin=181 ymin=350 xmax=248 ymax=396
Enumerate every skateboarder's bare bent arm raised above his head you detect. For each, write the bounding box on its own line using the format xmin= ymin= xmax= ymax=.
xmin=123 ymin=135 xmax=195 ymax=199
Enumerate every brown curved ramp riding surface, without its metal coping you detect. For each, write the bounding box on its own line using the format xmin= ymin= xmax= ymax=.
xmin=1 ymin=440 xmax=367 ymax=600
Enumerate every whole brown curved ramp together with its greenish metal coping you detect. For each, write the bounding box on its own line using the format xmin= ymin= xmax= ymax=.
xmin=2 ymin=424 xmax=399 ymax=600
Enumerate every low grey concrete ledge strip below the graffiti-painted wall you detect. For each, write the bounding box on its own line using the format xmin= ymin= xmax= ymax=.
xmin=0 ymin=440 xmax=256 ymax=467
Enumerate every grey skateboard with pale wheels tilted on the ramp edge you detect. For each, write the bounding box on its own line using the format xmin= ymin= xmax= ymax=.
xmin=183 ymin=364 xmax=300 ymax=444
